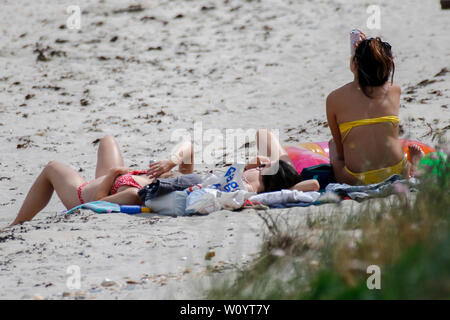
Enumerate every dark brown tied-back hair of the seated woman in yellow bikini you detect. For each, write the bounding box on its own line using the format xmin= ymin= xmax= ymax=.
xmin=353 ymin=37 xmax=395 ymax=98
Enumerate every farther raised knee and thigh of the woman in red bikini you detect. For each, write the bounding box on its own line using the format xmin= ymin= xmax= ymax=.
xmin=95 ymin=136 xmax=124 ymax=178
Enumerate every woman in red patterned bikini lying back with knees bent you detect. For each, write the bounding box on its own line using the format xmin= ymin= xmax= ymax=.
xmin=11 ymin=136 xmax=194 ymax=225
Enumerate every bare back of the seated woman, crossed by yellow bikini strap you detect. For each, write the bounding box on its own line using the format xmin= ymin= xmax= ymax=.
xmin=332 ymin=82 xmax=403 ymax=172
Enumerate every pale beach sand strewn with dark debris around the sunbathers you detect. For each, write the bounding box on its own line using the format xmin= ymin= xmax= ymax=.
xmin=0 ymin=0 xmax=450 ymax=299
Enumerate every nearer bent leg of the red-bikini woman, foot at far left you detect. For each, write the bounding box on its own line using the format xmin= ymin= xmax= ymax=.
xmin=11 ymin=161 xmax=84 ymax=225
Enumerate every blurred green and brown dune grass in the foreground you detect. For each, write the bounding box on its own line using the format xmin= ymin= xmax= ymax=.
xmin=208 ymin=151 xmax=450 ymax=299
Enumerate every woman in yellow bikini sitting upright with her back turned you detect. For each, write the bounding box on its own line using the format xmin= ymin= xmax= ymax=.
xmin=326 ymin=33 xmax=423 ymax=185
